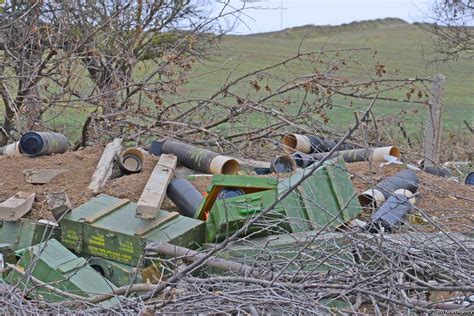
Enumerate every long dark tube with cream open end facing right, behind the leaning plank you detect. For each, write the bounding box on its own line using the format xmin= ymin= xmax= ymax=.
xmin=161 ymin=140 xmax=240 ymax=174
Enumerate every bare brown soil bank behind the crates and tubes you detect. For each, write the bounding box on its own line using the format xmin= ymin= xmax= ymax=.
xmin=0 ymin=146 xmax=474 ymax=233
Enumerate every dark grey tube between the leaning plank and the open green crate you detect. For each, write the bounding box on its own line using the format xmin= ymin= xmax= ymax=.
xmin=166 ymin=178 xmax=203 ymax=217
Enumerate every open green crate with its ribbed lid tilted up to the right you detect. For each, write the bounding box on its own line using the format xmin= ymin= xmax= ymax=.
xmin=196 ymin=159 xmax=361 ymax=242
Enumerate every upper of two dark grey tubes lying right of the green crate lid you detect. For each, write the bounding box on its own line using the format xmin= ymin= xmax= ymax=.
xmin=359 ymin=170 xmax=420 ymax=208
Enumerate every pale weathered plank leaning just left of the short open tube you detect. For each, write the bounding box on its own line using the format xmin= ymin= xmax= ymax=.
xmin=88 ymin=138 xmax=122 ymax=194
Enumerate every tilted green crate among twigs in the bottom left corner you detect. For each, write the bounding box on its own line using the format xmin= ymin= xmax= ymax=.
xmin=6 ymin=239 xmax=118 ymax=306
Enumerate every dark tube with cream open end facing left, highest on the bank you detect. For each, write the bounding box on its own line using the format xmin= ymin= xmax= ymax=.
xmin=282 ymin=134 xmax=354 ymax=154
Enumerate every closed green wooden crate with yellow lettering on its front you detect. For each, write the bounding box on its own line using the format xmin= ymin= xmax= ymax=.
xmin=60 ymin=195 xmax=204 ymax=265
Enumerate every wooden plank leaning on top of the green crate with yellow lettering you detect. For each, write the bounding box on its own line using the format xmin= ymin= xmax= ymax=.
xmin=135 ymin=154 xmax=178 ymax=219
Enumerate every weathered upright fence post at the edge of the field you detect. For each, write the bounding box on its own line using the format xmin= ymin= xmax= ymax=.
xmin=423 ymin=74 xmax=446 ymax=167
